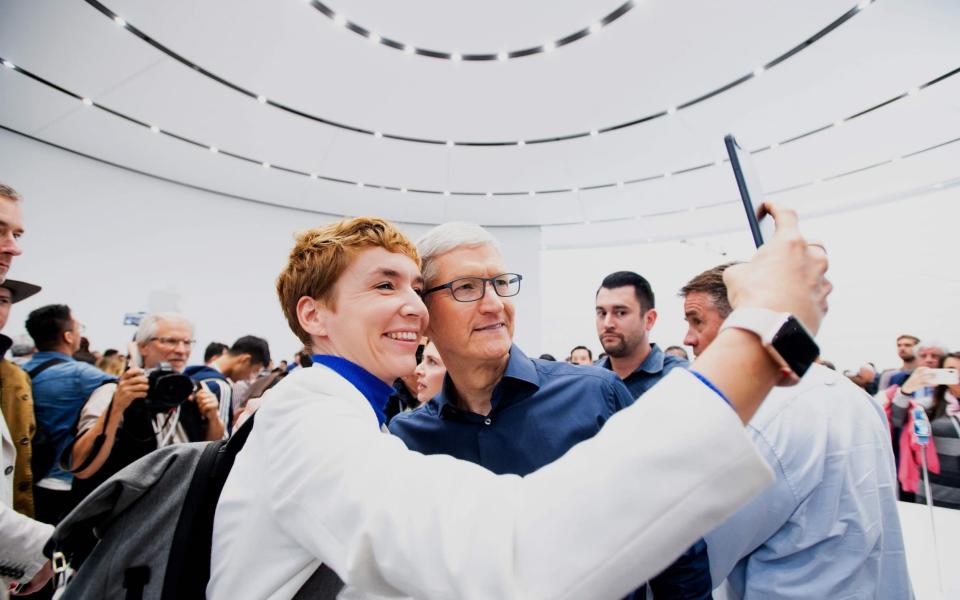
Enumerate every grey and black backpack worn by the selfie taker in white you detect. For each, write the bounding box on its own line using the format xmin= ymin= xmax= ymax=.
xmin=44 ymin=417 xmax=343 ymax=600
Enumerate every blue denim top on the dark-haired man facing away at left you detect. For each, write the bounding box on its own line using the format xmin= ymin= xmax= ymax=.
xmin=23 ymin=352 xmax=116 ymax=482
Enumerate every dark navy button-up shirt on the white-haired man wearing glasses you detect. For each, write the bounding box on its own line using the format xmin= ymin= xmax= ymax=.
xmin=389 ymin=346 xmax=710 ymax=598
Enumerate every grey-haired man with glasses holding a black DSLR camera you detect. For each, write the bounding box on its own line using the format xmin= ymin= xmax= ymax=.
xmin=70 ymin=313 xmax=225 ymax=498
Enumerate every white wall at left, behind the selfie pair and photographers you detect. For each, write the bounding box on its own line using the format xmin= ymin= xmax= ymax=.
xmin=0 ymin=131 xmax=540 ymax=362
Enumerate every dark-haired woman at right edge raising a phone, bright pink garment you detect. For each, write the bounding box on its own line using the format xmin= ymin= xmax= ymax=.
xmin=890 ymin=352 xmax=960 ymax=508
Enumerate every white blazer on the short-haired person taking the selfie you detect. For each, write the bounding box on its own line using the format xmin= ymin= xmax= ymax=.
xmin=207 ymin=365 xmax=772 ymax=600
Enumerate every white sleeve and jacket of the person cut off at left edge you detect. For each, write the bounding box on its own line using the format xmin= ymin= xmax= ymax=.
xmin=0 ymin=406 xmax=53 ymax=596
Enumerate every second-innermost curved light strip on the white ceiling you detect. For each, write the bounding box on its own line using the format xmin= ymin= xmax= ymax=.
xmin=86 ymin=0 xmax=874 ymax=147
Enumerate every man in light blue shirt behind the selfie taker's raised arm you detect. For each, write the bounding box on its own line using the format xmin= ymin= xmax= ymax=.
xmin=680 ymin=265 xmax=913 ymax=600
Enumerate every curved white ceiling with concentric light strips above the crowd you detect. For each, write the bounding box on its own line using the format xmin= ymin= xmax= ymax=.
xmin=0 ymin=0 xmax=960 ymax=232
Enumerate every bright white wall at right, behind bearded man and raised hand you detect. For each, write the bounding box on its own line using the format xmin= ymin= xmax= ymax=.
xmin=541 ymin=187 xmax=960 ymax=369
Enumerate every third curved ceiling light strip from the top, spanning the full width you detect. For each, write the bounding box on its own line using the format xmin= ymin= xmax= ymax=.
xmin=0 ymin=57 xmax=960 ymax=197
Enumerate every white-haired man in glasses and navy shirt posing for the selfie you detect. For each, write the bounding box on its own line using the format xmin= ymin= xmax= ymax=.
xmin=389 ymin=223 xmax=712 ymax=598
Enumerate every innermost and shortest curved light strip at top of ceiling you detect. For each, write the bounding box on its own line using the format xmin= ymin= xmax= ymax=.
xmin=308 ymin=0 xmax=635 ymax=62
